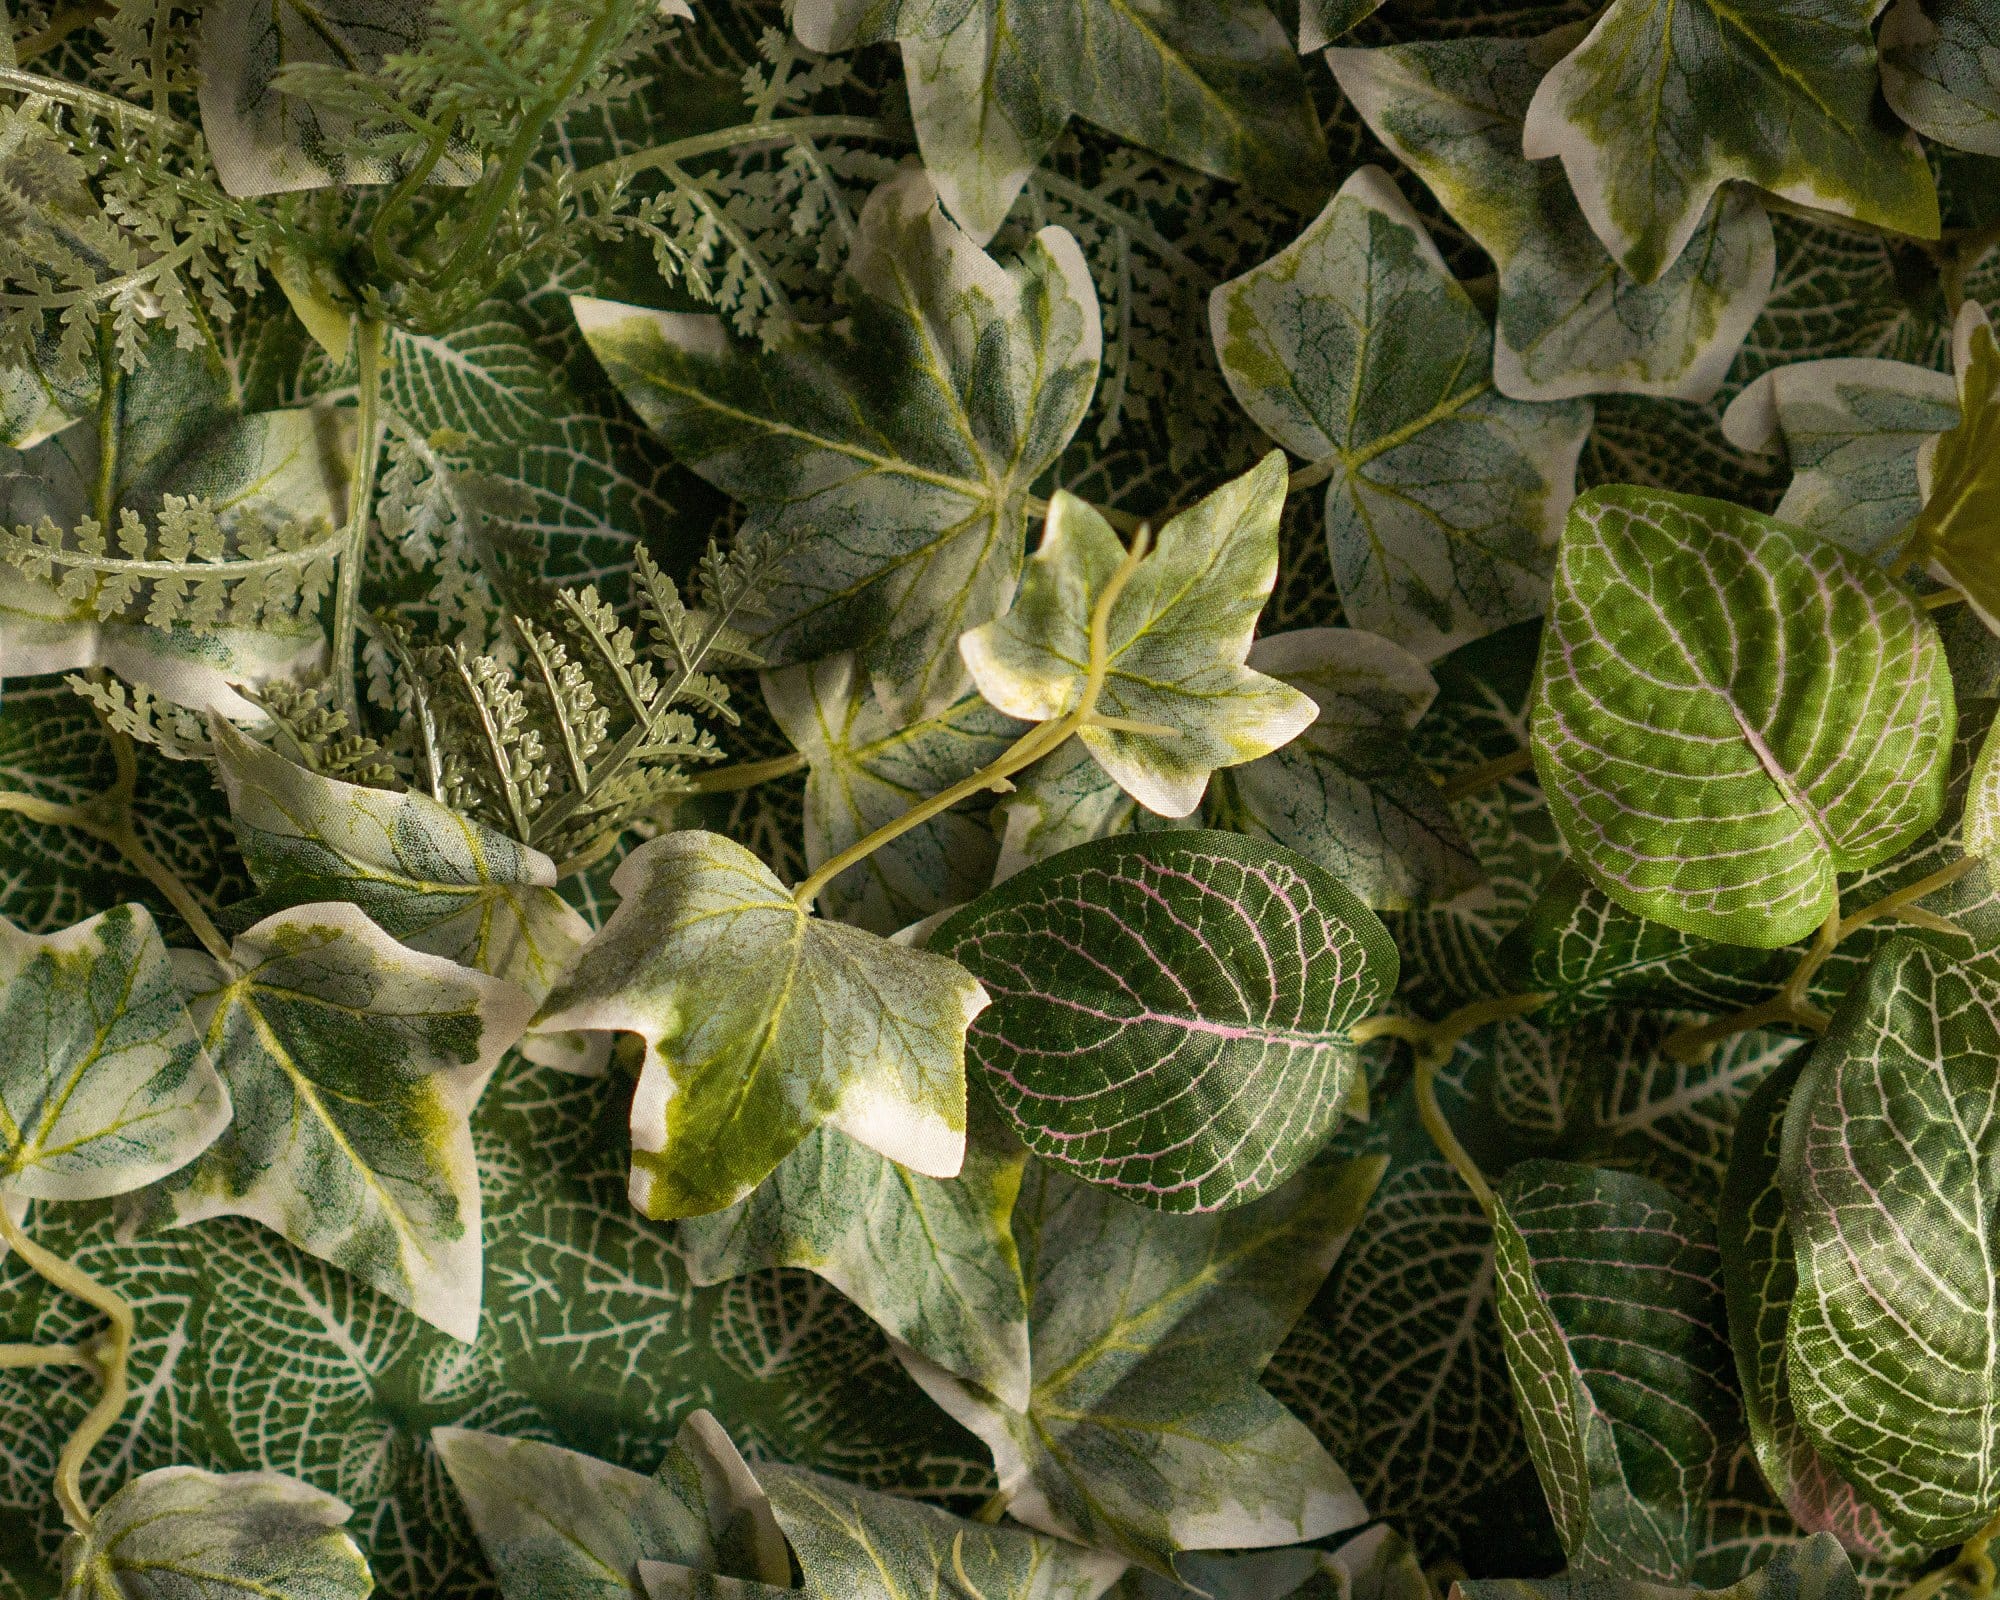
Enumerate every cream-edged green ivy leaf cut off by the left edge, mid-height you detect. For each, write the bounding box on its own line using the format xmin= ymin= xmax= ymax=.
xmin=0 ymin=906 xmax=230 ymax=1200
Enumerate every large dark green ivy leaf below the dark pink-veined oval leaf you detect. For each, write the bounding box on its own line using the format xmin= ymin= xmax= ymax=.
xmin=898 ymin=1160 xmax=1382 ymax=1576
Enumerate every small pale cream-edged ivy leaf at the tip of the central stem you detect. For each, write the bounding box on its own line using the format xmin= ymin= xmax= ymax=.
xmin=958 ymin=450 xmax=1316 ymax=816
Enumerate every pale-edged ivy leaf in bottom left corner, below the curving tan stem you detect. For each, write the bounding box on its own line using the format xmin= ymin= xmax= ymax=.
xmin=62 ymin=1466 xmax=374 ymax=1600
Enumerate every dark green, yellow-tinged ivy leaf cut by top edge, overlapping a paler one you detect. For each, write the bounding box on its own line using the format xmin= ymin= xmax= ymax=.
xmin=1522 ymin=0 xmax=1938 ymax=284
